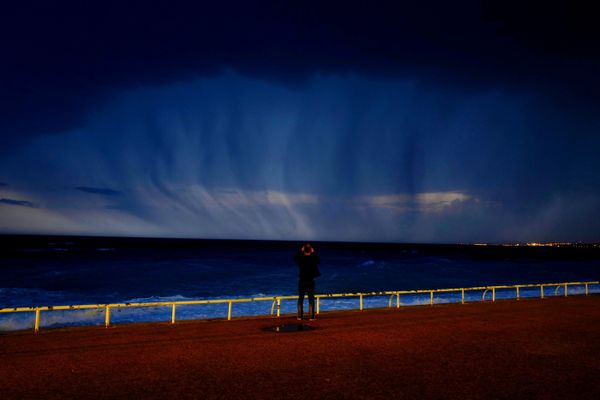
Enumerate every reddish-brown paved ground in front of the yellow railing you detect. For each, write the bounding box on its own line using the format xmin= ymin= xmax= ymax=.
xmin=0 ymin=296 xmax=600 ymax=400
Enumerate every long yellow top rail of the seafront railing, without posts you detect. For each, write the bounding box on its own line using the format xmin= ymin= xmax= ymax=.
xmin=0 ymin=281 xmax=600 ymax=313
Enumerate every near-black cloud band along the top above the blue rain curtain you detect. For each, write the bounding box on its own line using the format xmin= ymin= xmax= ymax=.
xmin=0 ymin=1 xmax=600 ymax=144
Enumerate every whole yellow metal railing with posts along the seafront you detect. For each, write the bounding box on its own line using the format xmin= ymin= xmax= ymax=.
xmin=0 ymin=281 xmax=600 ymax=333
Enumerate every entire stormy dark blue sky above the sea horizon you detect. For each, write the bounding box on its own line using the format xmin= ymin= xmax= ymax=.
xmin=0 ymin=1 xmax=600 ymax=243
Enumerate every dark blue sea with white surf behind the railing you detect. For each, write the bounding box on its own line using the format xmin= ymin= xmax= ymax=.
xmin=0 ymin=235 xmax=600 ymax=331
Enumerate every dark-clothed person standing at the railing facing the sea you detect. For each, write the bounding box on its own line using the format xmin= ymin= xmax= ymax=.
xmin=294 ymin=243 xmax=321 ymax=320
